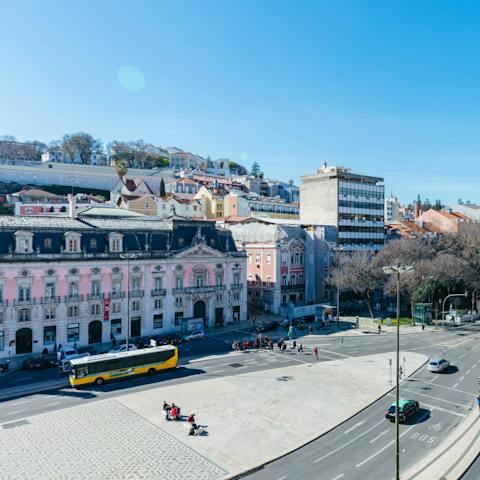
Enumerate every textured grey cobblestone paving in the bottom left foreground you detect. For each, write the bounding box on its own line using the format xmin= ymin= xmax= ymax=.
xmin=0 ymin=400 xmax=227 ymax=480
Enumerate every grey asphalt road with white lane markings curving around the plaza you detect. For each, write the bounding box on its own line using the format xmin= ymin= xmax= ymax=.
xmin=0 ymin=329 xmax=480 ymax=480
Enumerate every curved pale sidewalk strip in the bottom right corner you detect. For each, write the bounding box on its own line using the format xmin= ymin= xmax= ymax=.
xmin=402 ymin=406 xmax=480 ymax=480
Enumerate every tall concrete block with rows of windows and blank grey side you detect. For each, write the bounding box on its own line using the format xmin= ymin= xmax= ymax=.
xmin=300 ymin=164 xmax=385 ymax=250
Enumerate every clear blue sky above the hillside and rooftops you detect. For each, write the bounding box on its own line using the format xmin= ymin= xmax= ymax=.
xmin=0 ymin=0 xmax=480 ymax=202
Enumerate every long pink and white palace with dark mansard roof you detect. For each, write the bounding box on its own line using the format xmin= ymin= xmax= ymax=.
xmin=0 ymin=216 xmax=247 ymax=356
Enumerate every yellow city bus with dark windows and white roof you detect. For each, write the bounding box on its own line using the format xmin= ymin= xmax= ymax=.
xmin=70 ymin=345 xmax=178 ymax=388
